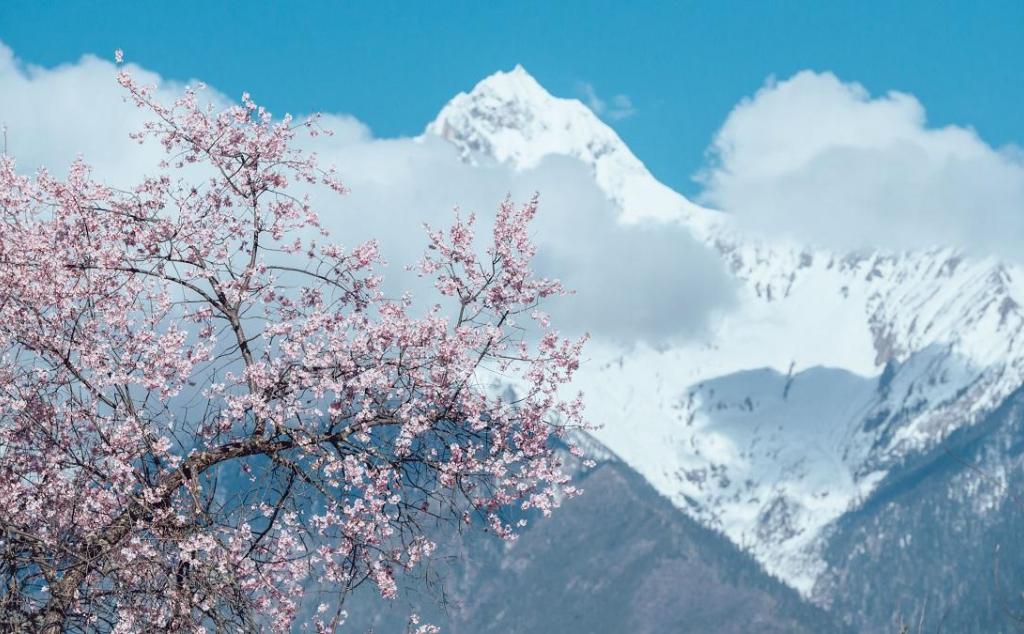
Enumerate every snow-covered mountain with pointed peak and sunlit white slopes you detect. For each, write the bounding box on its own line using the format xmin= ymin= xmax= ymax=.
xmin=426 ymin=67 xmax=1024 ymax=595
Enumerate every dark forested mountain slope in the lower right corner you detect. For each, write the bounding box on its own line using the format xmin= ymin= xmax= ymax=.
xmin=815 ymin=391 xmax=1024 ymax=634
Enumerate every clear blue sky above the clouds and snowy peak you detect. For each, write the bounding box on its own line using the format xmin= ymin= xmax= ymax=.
xmin=0 ymin=0 xmax=1024 ymax=194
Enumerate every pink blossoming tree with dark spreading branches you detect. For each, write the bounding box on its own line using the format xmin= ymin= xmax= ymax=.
xmin=0 ymin=61 xmax=583 ymax=632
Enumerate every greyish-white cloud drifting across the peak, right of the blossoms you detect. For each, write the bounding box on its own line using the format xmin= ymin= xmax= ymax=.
xmin=290 ymin=136 xmax=734 ymax=343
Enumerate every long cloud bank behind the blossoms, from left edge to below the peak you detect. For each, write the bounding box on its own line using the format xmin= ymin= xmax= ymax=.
xmin=0 ymin=44 xmax=733 ymax=343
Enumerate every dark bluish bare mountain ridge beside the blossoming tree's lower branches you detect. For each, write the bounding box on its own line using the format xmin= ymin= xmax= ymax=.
xmin=348 ymin=460 xmax=842 ymax=634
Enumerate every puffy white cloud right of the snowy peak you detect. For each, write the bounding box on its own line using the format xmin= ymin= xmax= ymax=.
xmin=698 ymin=71 xmax=1024 ymax=258
